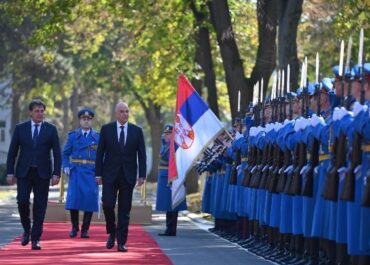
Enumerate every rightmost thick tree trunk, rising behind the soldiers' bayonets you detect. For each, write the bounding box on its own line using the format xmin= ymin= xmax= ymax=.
xmin=278 ymin=0 xmax=303 ymax=89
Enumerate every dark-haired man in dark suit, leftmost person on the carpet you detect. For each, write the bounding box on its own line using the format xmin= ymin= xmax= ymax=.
xmin=7 ymin=100 xmax=61 ymax=250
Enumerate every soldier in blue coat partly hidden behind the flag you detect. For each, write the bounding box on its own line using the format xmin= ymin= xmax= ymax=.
xmin=156 ymin=124 xmax=187 ymax=236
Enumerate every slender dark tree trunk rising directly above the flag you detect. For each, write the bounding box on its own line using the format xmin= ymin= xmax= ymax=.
xmin=190 ymin=0 xmax=219 ymax=117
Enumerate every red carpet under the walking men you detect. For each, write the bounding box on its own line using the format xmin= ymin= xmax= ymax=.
xmin=0 ymin=223 xmax=172 ymax=265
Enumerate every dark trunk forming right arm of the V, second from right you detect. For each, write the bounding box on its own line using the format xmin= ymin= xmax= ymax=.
xmin=248 ymin=0 xmax=277 ymax=99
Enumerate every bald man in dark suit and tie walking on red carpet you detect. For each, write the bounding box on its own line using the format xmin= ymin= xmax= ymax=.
xmin=95 ymin=102 xmax=146 ymax=252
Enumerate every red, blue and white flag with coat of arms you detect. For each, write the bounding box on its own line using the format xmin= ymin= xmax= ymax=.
xmin=168 ymin=74 xmax=224 ymax=209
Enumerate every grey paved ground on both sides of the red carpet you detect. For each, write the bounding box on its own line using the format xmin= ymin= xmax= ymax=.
xmin=0 ymin=185 xmax=273 ymax=265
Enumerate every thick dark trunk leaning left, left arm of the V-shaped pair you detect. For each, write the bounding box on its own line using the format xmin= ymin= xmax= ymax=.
xmin=208 ymin=0 xmax=247 ymax=119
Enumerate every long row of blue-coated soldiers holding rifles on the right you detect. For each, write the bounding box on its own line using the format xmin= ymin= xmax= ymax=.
xmin=202 ymin=51 xmax=370 ymax=265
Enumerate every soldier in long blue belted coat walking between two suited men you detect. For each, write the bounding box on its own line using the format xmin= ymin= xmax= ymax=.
xmin=63 ymin=108 xmax=99 ymax=238
